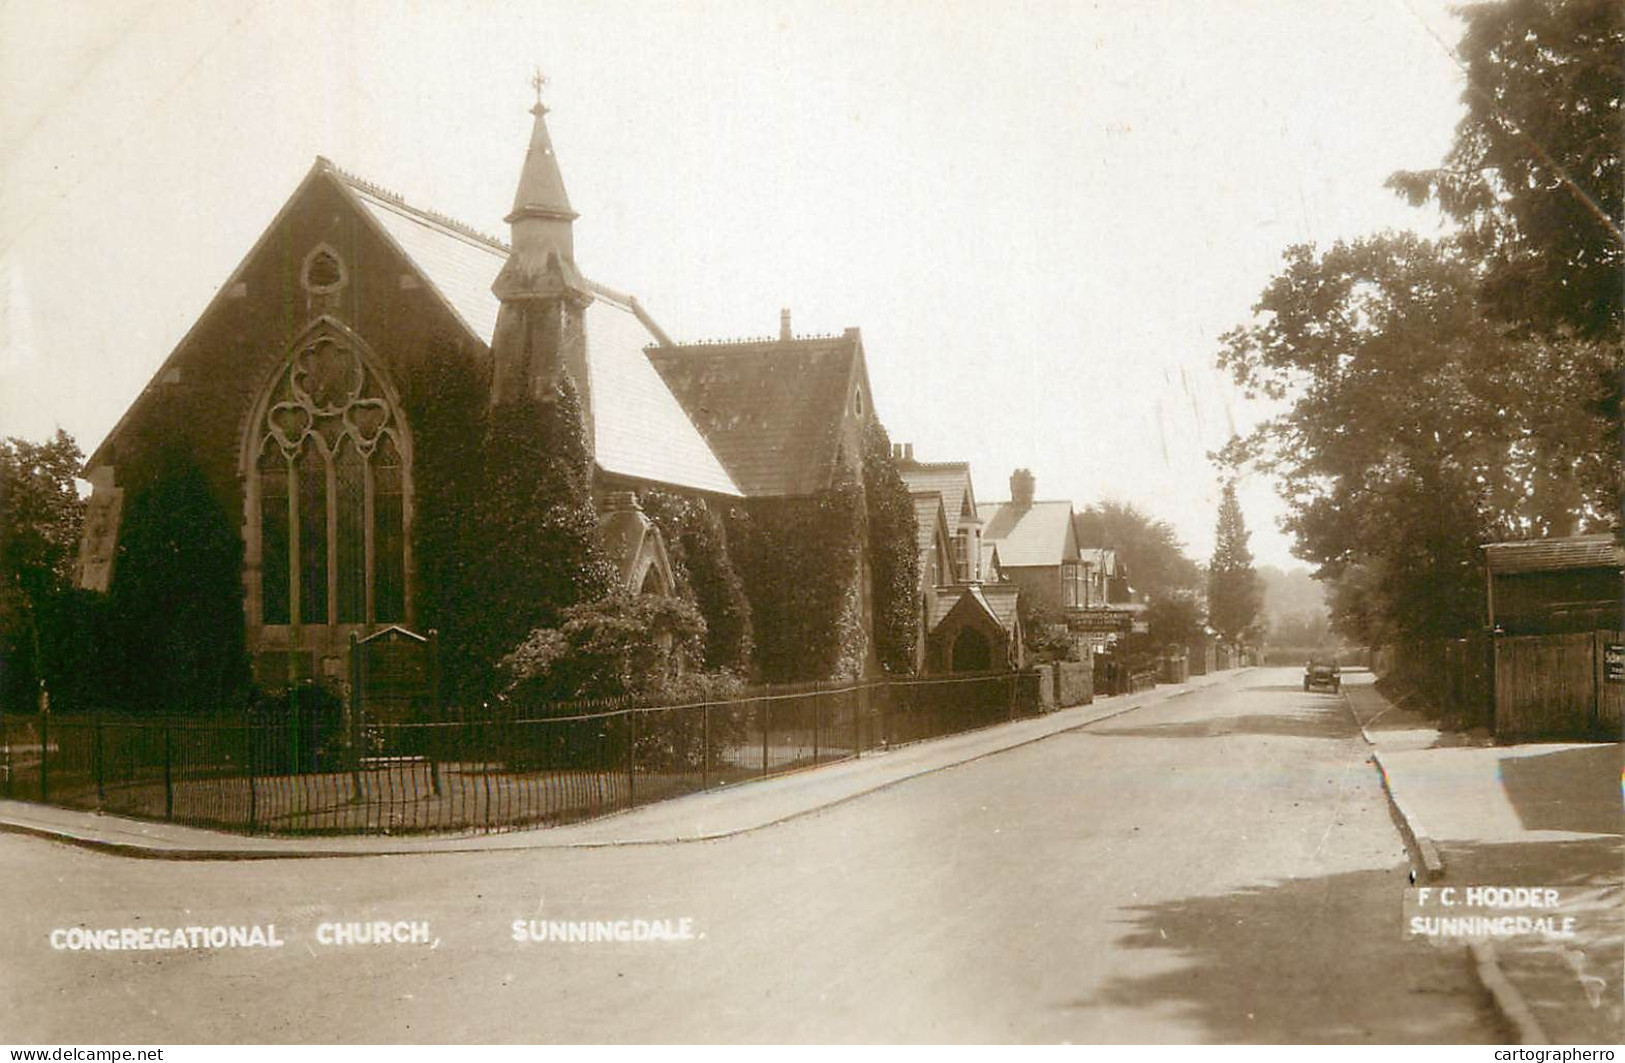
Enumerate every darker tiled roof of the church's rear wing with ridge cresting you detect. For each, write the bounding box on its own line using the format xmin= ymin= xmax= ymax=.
xmin=648 ymin=328 xmax=869 ymax=496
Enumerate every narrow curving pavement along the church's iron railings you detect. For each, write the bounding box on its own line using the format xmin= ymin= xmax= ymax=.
xmin=0 ymin=670 xmax=1246 ymax=860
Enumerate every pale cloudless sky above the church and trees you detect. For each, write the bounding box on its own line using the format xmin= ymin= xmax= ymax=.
xmin=0 ymin=0 xmax=1463 ymax=566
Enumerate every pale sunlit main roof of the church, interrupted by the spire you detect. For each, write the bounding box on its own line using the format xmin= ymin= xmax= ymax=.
xmin=332 ymin=169 xmax=739 ymax=496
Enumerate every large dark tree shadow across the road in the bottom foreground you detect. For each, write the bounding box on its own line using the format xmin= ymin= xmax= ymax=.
xmin=1066 ymin=863 xmax=1506 ymax=1043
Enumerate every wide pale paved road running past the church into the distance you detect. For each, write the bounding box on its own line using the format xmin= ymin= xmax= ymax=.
xmin=0 ymin=670 xmax=1506 ymax=1043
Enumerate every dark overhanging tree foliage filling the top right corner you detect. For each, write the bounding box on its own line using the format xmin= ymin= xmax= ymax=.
xmin=1389 ymin=0 xmax=1625 ymax=341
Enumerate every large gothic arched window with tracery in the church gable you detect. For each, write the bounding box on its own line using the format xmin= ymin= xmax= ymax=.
xmin=249 ymin=328 xmax=411 ymax=624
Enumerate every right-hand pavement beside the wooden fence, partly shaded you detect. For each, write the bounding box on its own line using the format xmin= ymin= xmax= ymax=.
xmin=1344 ymin=673 xmax=1625 ymax=1043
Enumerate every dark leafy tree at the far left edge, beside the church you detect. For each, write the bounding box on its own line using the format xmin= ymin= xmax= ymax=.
xmin=0 ymin=429 xmax=85 ymax=712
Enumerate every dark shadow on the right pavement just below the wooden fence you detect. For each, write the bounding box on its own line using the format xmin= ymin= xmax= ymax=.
xmin=1500 ymin=744 xmax=1625 ymax=838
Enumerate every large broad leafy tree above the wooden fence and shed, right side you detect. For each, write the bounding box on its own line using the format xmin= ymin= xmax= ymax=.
xmin=1219 ymin=234 xmax=1619 ymax=639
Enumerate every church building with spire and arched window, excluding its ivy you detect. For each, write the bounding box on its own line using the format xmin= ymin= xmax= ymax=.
xmin=78 ymin=99 xmax=873 ymax=692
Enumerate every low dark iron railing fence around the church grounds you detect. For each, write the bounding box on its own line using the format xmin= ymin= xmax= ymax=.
xmin=0 ymin=673 xmax=1037 ymax=834
